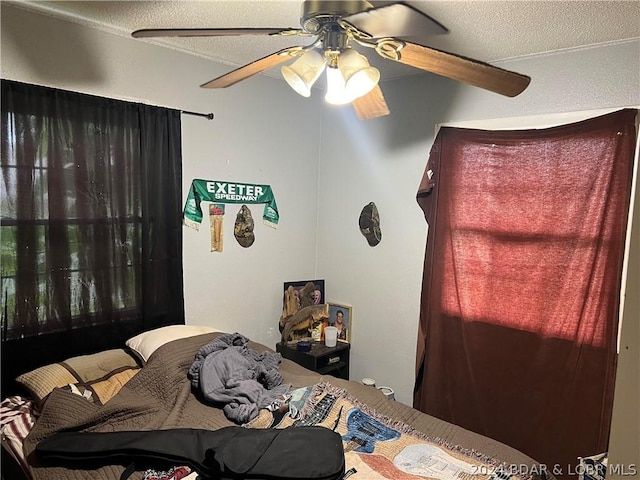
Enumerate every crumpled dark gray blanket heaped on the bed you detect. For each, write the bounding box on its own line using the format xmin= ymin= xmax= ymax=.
xmin=189 ymin=333 xmax=291 ymax=424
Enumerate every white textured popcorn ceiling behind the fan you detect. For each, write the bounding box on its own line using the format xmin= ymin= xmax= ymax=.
xmin=6 ymin=0 xmax=640 ymax=79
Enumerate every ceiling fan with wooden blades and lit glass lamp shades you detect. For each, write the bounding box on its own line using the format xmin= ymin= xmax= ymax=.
xmin=131 ymin=0 xmax=531 ymax=119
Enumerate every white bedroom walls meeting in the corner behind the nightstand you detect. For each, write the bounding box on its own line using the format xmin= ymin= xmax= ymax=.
xmin=1 ymin=3 xmax=640 ymax=463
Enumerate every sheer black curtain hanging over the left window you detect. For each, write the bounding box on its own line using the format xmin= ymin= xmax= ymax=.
xmin=0 ymin=80 xmax=184 ymax=395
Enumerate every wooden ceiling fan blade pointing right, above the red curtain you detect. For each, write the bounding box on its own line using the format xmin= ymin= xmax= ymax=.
xmin=384 ymin=40 xmax=531 ymax=97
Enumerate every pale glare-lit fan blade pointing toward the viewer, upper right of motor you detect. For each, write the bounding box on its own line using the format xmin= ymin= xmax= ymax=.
xmin=340 ymin=3 xmax=449 ymax=38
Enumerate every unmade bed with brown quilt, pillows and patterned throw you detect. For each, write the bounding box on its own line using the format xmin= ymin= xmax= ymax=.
xmin=3 ymin=326 xmax=554 ymax=480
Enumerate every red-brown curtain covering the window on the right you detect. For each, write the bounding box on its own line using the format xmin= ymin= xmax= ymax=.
xmin=414 ymin=109 xmax=636 ymax=477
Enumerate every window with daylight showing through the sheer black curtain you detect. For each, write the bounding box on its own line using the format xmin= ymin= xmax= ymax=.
xmin=0 ymin=113 xmax=141 ymax=338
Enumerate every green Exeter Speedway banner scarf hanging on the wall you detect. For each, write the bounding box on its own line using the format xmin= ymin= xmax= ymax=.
xmin=182 ymin=179 xmax=279 ymax=230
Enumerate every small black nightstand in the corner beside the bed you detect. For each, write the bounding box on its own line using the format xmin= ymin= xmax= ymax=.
xmin=276 ymin=342 xmax=351 ymax=380
